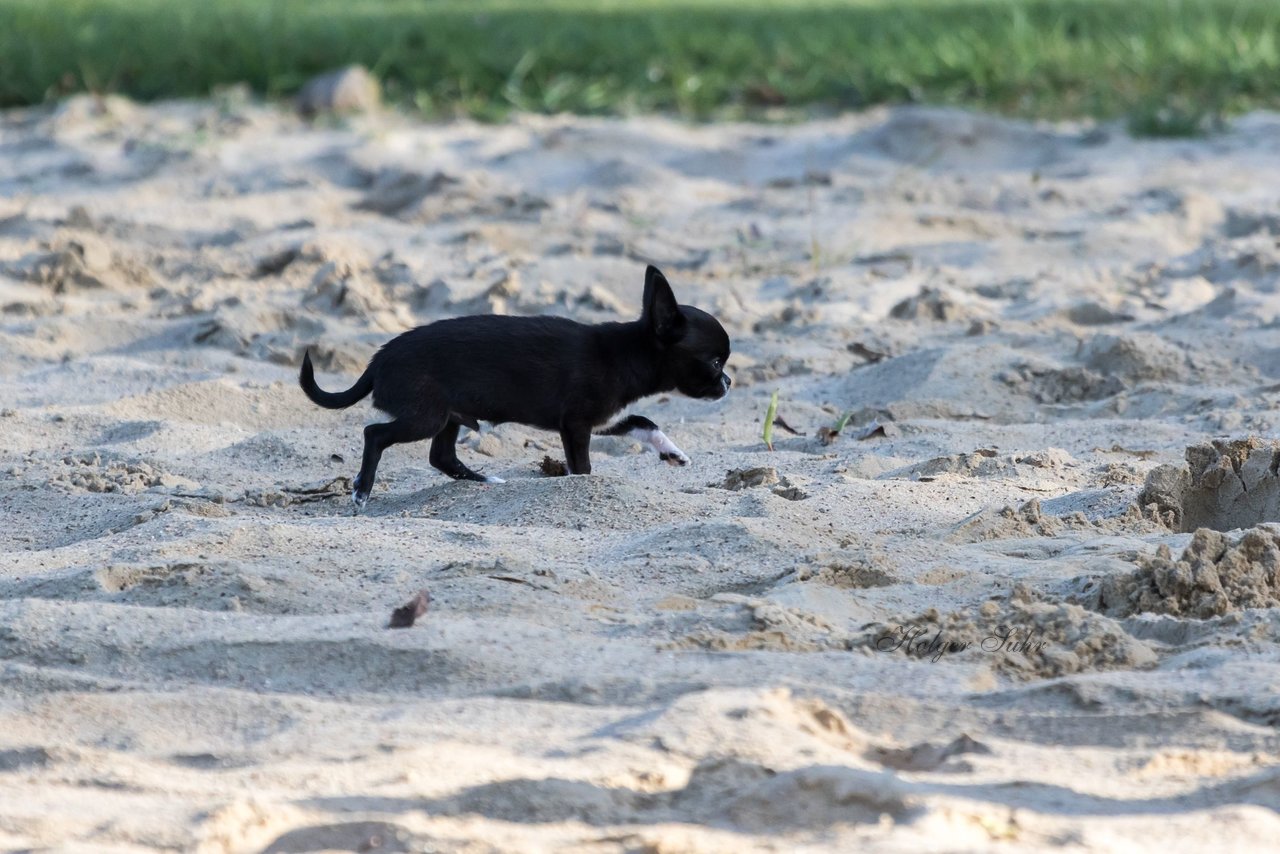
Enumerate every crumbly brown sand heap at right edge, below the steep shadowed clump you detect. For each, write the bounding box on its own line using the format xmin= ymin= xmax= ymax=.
xmin=1098 ymin=528 xmax=1280 ymax=620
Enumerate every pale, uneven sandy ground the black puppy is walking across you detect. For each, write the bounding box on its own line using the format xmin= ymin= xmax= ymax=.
xmin=0 ymin=96 xmax=1280 ymax=853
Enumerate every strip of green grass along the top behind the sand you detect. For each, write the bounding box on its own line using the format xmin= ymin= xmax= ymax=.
xmin=0 ymin=0 xmax=1280 ymax=134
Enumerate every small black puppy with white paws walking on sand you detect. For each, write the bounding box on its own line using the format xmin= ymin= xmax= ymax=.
xmin=298 ymin=266 xmax=730 ymax=506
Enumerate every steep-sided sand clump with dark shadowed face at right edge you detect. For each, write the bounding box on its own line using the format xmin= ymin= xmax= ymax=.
xmin=1138 ymin=437 xmax=1280 ymax=533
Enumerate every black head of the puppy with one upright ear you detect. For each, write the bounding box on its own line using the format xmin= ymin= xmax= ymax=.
xmin=640 ymin=266 xmax=732 ymax=401
